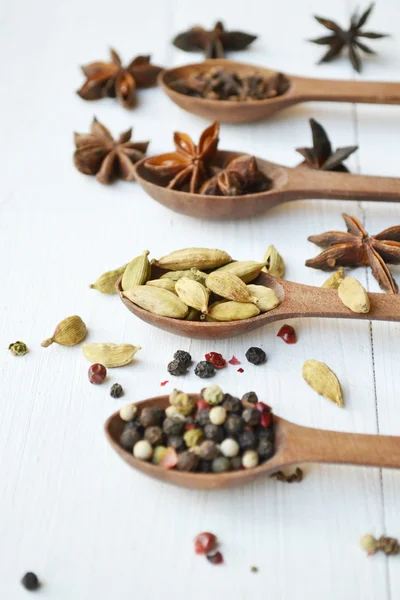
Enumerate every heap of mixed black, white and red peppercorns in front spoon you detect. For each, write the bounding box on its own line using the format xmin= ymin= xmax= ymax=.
xmin=120 ymin=384 xmax=274 ymax=473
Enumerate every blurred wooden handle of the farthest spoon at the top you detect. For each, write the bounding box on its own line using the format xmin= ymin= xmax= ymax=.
xmin=293 ymin=77 xmax=400 ymax=104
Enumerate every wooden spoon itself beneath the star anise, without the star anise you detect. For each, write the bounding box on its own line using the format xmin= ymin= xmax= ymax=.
xmin=135 ymin=150 xmax=400 ymax=220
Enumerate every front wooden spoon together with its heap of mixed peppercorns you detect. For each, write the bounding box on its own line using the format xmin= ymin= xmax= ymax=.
xmin=105 ymin=392 xmax=400 ymax=490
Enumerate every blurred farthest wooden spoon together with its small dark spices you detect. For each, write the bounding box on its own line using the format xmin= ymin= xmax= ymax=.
xmin=158 ymin=59 xmax=400 ymax=123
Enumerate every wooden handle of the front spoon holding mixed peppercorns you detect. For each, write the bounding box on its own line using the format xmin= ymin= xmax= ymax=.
xmin=287 ymin=426 xmax=400 ymax=469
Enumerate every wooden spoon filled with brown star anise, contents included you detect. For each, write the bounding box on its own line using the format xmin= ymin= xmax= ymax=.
xmin=135 ymin=122 xmax=400 ymax=220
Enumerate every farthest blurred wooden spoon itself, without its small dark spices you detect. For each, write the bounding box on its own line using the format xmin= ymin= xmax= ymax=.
xmin=158 ymin=59 xmax=400 ymax=123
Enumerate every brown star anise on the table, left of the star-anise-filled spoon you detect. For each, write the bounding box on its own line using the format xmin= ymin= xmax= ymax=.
xmin=74 ymin=118 xmax=149 ymax=183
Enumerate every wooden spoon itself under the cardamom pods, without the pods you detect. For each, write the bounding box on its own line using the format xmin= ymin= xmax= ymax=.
xmin=117 ymin=267 xmax=400 ymax=340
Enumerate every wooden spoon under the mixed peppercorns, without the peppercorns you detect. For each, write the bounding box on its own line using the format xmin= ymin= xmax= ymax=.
xmin=105 ymin=394 xmax=400 ymax=490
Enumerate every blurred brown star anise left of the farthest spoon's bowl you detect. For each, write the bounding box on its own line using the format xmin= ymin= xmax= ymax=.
xmin=77 ymin=49 xmax=162 ymax=108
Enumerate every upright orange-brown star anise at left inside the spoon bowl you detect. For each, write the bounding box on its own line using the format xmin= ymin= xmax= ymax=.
xmin=145 ymin=121 xmax=219 ymax=193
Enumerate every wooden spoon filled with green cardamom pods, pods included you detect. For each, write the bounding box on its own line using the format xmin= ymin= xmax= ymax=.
xmin=116 ymin=246 xmax=400 ymax=340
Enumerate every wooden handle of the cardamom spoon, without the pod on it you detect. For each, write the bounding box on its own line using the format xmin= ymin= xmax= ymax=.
xmin=276 ymin=280 xmax=400 ymax=321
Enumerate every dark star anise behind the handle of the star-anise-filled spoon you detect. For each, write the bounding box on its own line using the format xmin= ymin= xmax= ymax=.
xmin=296 ymin=119 xmax=358 ymax=173
